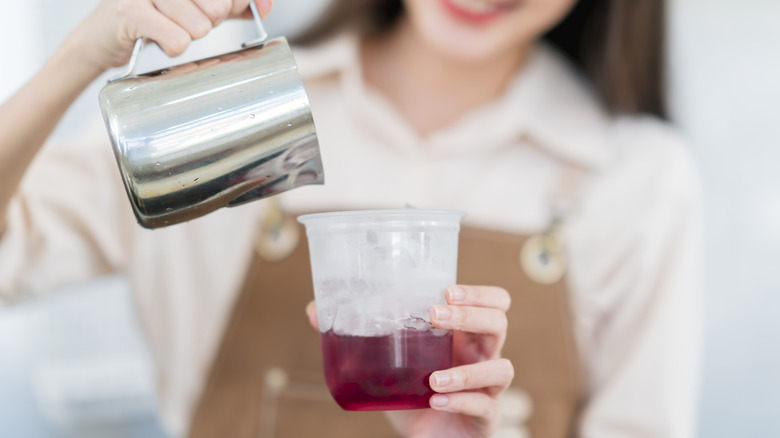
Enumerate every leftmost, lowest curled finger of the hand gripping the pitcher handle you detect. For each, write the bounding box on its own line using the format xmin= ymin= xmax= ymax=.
xmin=125 ymin=2 xmax=192 ymax=56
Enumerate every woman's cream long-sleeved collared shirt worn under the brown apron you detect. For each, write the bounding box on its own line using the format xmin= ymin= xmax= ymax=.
xmin=0 ymin=36 xmax=702 ymax=438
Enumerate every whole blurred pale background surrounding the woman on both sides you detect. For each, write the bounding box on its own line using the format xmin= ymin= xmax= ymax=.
xmin=0 ymin=0 xmax=780 ymax=438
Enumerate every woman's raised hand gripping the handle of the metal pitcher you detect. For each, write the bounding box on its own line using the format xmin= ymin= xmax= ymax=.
xmin=72 ymin=0 xmax=273 ymax=70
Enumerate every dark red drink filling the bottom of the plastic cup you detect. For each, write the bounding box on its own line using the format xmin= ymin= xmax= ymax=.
xmin=320 ymin=329 xmax=452 ymax=411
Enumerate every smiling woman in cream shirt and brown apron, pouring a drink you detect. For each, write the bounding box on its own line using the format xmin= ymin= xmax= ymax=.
xmin=0 ymin=0 xmax=700 ymax=437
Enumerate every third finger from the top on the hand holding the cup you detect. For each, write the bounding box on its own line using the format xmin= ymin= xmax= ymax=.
xmin=428 ymin=358 xmax=515 ymax=393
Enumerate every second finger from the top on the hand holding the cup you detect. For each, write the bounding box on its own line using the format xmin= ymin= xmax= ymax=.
xmin=428 ymin=306 xmax=507 ymax=339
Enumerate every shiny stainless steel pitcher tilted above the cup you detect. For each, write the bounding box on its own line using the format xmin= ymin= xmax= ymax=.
xmin=100 ymin=2 xmax=324 ymax=228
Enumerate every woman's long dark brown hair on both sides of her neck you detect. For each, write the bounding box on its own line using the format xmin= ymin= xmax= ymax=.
xmin=295 ymin=0 xmax=666 ymax=118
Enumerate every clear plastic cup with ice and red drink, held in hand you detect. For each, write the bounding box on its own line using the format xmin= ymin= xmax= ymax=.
xmin=298 ymin=209 xmax=465 ymax=411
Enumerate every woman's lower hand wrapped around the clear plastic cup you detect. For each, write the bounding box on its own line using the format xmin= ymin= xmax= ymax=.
xmin=306 ymin=286 xmax=514 ymax=438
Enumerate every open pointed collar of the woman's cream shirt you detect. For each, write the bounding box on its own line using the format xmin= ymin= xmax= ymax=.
xmin=295 ymin=33 xmax=612 ymax=169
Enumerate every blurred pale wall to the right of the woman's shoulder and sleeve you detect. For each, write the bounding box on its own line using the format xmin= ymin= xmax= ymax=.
xmin=672 ymin=0 xmax=780 ymax=438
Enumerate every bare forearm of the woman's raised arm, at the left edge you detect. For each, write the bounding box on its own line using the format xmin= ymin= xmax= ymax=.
xmin=0 ymin=25 xmax=102 ymax=226
